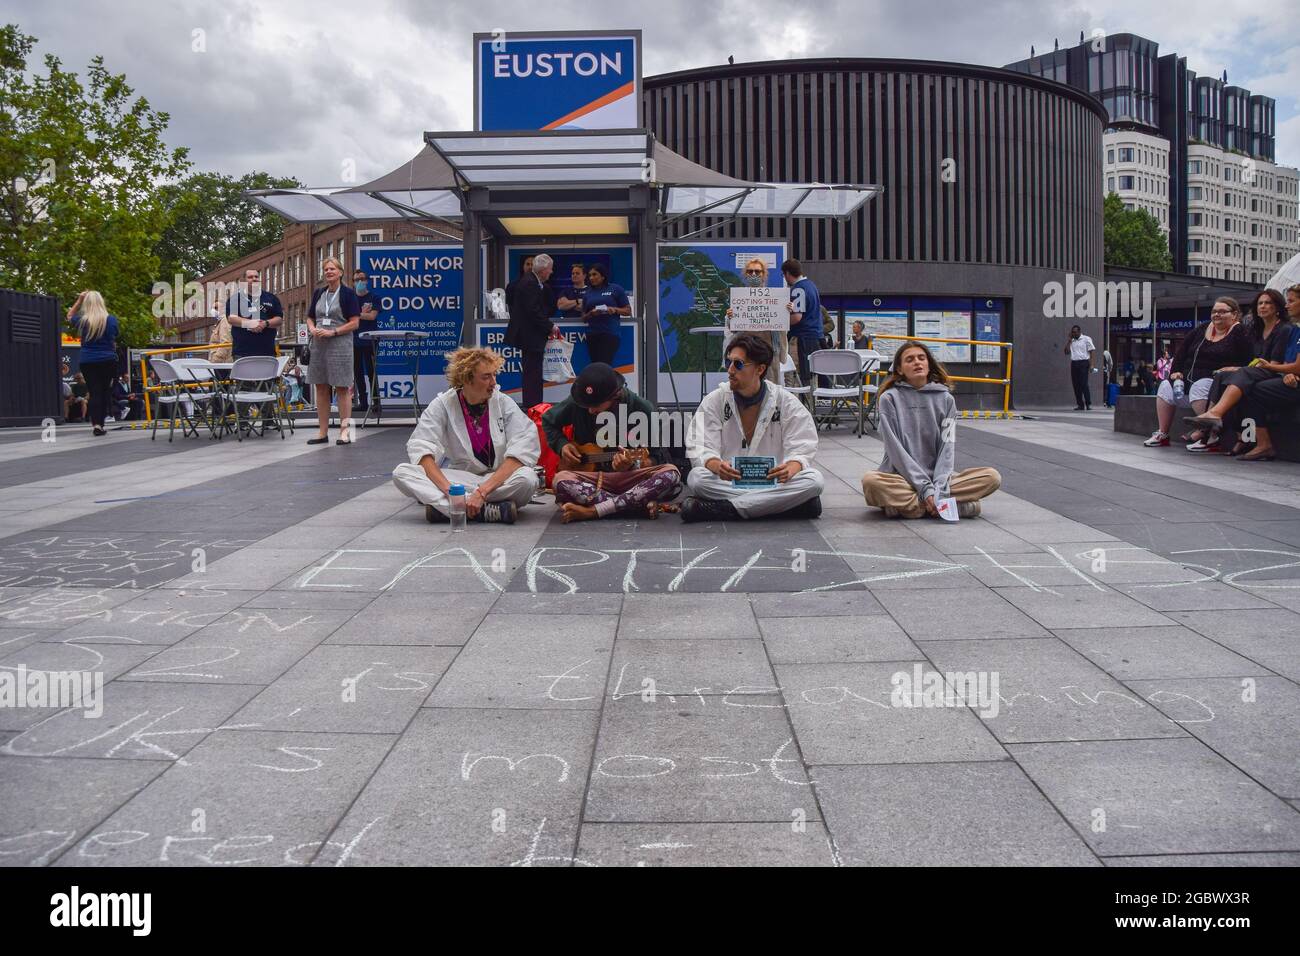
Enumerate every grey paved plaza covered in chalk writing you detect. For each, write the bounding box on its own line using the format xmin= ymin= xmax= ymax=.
xmin=0 ymin=410 xmax=1300 ymax=866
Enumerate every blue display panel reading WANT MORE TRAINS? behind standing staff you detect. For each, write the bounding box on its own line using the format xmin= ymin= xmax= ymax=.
xmin=356 ymin=243 xmax=482 ymax=401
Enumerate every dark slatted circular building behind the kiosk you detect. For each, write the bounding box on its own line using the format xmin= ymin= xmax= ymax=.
xmin=644 ymin=59 xmax=1106 ymax=407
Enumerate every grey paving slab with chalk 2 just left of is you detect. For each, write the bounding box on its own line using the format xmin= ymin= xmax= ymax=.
xmin=116 ymin=609 xmax=351 ymax=684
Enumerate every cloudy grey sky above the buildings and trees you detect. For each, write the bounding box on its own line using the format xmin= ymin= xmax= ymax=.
xmin=10 ymin=0 xmax=1300 ymax=186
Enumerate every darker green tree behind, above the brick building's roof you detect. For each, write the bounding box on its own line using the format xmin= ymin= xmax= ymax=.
xmin=157 ymin=173 xmax=302 ymax=282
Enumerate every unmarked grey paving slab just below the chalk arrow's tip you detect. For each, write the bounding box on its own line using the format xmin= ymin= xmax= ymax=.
xmin=878 ymin=588 xmax=1049 ymax=640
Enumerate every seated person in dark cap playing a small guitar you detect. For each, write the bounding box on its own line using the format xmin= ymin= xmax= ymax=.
xmin=542 ymin=362 xmax=681 ymax=524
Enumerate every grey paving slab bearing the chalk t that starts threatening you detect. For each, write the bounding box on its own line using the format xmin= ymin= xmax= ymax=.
xmin=428 ymin=614 xmax=618 ymax=710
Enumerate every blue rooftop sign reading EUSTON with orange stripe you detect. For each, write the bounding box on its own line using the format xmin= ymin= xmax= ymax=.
xmin=475 ymin=30 xmax=641 ymax=131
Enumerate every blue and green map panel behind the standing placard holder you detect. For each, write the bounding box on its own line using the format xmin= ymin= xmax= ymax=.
xmin=649 ymin=241 xmax=787 ymax=403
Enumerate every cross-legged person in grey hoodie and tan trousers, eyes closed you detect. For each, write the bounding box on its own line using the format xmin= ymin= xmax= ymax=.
xmin=862 ymin=342 xmax=1002 ymax=518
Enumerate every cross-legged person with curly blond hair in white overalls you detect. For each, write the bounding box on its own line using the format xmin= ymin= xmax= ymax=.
xmin=393 ymin=349 xmax=542 ymax=524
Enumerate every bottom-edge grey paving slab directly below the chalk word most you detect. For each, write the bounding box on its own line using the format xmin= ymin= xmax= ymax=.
xmin=577 ymin=819 xmax=835 ymax=866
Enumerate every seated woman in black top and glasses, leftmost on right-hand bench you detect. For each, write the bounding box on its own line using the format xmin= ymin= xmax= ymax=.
xmin=1143 ymin=295 xmax=1255 ymax=447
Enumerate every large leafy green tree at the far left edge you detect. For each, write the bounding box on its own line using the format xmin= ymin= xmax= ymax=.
xmin=0 ymin=25 xmax=190 ymax=316
